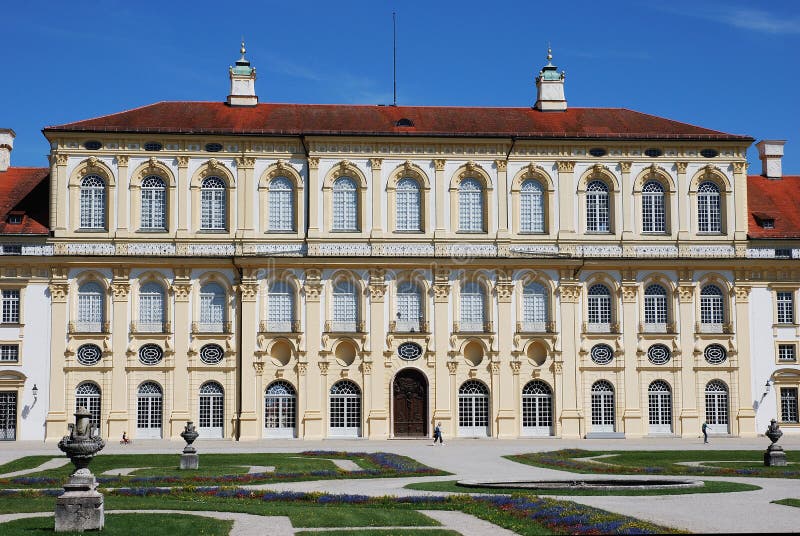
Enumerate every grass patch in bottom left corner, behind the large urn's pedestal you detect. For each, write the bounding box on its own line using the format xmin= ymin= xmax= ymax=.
xmin=0 ymin=514 xmax=233 ymax=536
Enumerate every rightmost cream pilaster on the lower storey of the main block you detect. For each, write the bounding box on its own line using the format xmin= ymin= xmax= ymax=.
xmin=733 ymin=281 xmax=757 ymax=437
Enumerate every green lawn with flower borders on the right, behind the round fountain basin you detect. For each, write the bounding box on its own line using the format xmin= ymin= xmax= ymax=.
xmin=506 ymin=449 xmax=800 ymax=478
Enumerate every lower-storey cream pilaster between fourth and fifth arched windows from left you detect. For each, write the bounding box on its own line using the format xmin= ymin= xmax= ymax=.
xmin=298 ymin=270 xmax=328 ymax=439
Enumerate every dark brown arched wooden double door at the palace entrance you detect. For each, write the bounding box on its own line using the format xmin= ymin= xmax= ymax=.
xmin=392 ymin=369 xmax=428 ymax=437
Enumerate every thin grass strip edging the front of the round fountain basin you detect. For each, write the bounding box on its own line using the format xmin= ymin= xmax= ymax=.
xmin=405 ymin=480 xmax=761 ymax=496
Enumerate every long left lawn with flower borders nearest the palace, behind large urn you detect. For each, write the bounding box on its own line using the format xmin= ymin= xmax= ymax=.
xmin=0 ymin=451 xmax=447 ymax=488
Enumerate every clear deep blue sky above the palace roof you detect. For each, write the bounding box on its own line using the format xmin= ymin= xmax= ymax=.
xmin=0 ymin=0 xmax=800 ymax=174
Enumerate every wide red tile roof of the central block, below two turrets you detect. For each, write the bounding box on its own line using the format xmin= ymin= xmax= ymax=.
xmin=44 ymin=102 xmax=753 ymax=143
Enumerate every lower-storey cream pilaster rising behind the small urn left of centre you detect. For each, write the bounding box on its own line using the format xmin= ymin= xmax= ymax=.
xmin=169 ymin=267 xmax=194 ymax=437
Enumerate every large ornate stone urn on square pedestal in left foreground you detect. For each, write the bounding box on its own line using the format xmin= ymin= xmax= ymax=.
xmin=55 ymin=407 xmax=106 ymax=532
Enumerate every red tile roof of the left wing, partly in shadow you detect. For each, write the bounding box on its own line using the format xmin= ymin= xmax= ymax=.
xmin=0 ymin=167 xmax=50 ymax=235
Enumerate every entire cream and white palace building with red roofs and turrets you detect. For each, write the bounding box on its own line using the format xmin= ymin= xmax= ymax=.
xmin=0 ymin=48 xmax=800 ymax=440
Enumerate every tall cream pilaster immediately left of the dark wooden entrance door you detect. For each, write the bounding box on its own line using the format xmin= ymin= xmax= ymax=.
xmin=364 ymin=270 xmax=389 ymax=439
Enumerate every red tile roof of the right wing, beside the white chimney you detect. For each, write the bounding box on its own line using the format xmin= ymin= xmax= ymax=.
xmin=747 ymin=175 xmax=800 ymax=238
